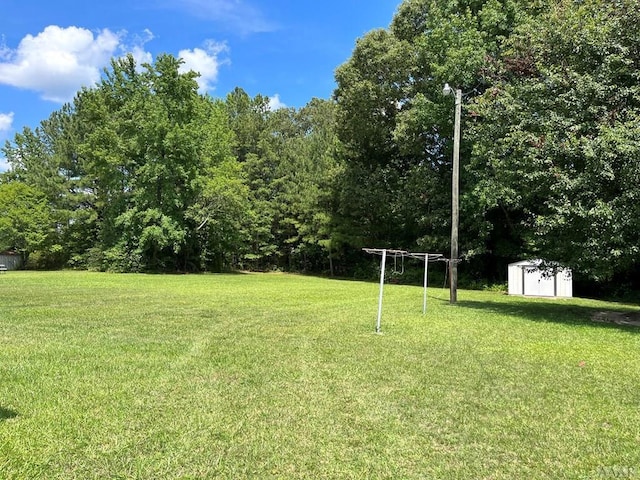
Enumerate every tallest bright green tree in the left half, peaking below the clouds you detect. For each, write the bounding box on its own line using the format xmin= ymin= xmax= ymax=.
xmin=76 ymin=56 xmax=206 ymax=270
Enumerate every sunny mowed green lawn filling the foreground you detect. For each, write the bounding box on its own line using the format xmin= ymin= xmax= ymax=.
xmin=0 ymin=272 xmax=640 ymax=480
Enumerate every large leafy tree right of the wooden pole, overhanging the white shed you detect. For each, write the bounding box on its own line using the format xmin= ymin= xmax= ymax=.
xmin=471 ymin=1 xmax=640 ymax=279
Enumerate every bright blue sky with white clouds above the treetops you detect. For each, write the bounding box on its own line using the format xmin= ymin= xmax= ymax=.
xmin=0 ymin=0 xmax=401 ymax=171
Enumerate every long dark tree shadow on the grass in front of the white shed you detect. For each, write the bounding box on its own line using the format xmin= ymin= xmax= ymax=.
xmin=458 ymin=297 xmax=640 ymax=334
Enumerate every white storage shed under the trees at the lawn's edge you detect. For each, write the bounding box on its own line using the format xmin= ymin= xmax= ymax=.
xmin=508 ymin=260 xmax=573 ymax=298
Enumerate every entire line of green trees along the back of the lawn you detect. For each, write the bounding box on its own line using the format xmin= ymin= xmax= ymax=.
xmin=0 ymin=0 xmax=640 ymax=294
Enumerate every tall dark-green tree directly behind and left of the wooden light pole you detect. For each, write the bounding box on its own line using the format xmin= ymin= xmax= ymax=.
xmin=335 ymin=0 xmax=520 ymax=262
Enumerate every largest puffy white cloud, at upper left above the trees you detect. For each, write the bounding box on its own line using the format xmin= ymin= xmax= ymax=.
xmin=0 ymin=25 xmax=153 ymax=103
